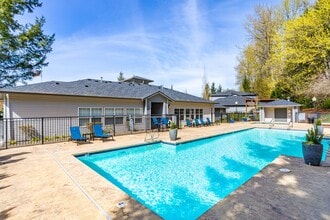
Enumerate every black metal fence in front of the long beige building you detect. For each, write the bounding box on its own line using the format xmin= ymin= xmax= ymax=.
xmin=0 ymin=115 xmax=181 ymax=148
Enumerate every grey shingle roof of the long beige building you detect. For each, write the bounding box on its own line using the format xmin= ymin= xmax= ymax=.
xmin=0 ymin=79 xmax=213 ymax=103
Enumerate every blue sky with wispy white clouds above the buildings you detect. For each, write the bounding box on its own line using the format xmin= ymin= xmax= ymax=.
xmin=27 ymin=0 xmax=281 ymax=96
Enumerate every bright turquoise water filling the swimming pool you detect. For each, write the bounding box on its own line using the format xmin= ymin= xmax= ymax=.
xmin=77 ymin=129 xmax=328 ymax=219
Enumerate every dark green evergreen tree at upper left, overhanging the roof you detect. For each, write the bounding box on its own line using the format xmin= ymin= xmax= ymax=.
xmin=0 ymin=0 xmax=55 ymax=88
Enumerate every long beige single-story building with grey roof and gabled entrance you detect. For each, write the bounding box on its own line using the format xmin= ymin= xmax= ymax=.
xmin=0 ymin=76 xmax=214 ymax=132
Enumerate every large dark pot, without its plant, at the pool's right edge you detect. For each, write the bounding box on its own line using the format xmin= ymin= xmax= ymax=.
xmin=302 ymin=142 xmax=323 ymax=166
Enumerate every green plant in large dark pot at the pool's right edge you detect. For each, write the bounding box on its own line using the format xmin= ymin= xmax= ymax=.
xmin=302 ymin=126 xmax=323 ymax=166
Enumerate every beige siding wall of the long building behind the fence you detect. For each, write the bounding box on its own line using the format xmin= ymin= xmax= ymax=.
xmin=4 ymin=94 xmax=213 ymax=139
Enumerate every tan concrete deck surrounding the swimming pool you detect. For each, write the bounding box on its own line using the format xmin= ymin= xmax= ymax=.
xmin=0 ymin=123 xmax=330 ymax=219
